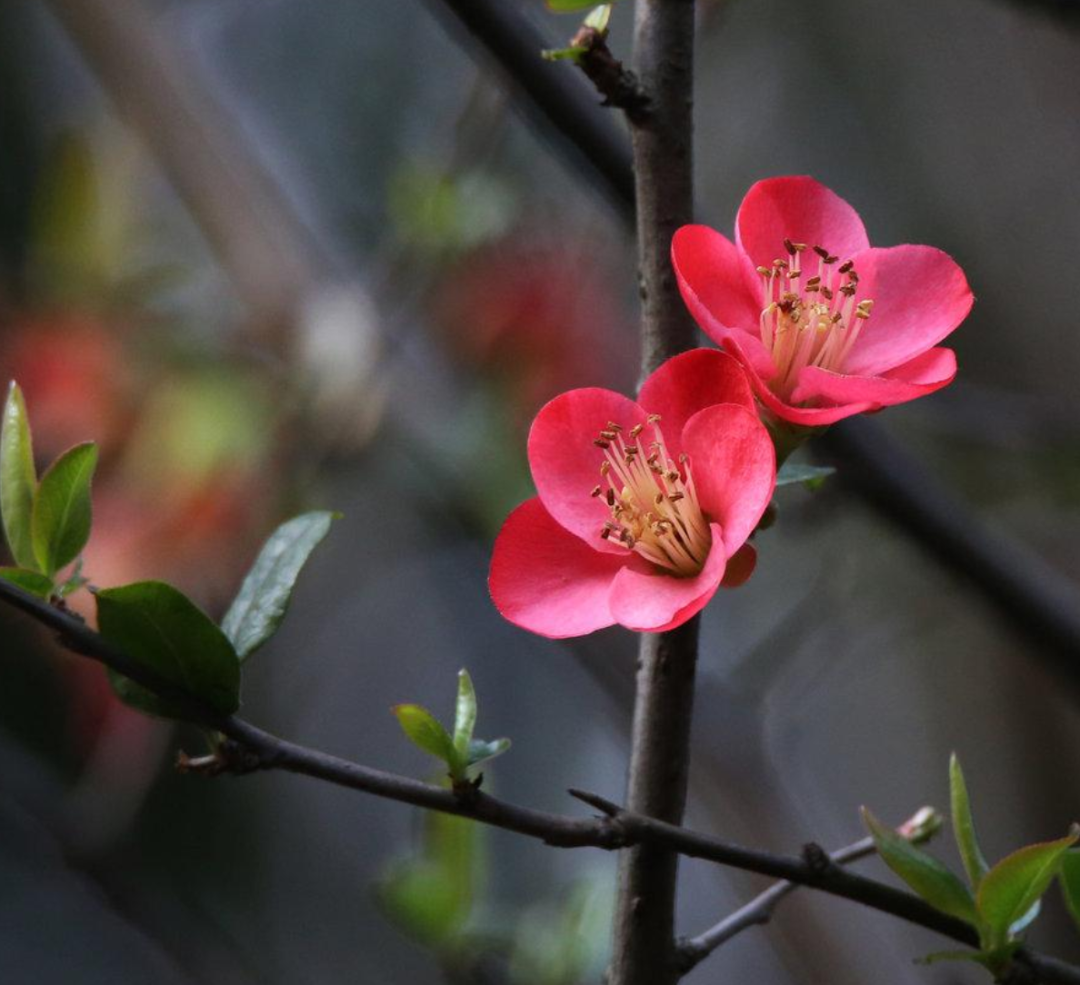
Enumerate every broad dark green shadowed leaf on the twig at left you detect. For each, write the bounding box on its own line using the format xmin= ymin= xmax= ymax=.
xmin=95 ymin=581 xmax=240 ymax=718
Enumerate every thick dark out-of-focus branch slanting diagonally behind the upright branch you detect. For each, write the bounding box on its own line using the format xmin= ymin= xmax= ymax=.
xmin=429 ymin=0 xmax=1080 ymax=693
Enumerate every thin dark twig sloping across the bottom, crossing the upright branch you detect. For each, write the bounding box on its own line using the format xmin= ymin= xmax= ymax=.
xmin=0 ymin=578 xmax=1080 ymax=985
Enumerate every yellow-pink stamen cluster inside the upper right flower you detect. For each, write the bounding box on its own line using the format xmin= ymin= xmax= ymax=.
xmin=757 ymin=240 xmax=874 ymax=400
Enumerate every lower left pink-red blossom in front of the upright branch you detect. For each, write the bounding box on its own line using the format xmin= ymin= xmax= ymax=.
xmin=488 ymin=349 xmax=775 ymax=638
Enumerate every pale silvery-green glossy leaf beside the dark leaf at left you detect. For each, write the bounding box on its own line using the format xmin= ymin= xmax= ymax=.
xmin=221 ymin=510 xmax=341 ymax=661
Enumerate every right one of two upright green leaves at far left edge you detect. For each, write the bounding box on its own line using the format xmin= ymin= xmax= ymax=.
xmin=30 ymin=442 xmax=97 ymax=577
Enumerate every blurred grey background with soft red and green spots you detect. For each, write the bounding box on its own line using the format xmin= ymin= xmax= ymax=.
xmin=0 ymin=0 xmax=1080 ymax=985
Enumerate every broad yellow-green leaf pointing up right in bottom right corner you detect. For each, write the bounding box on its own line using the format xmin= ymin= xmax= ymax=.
xmin=975 ymin=831 xmax=1080 ymax=947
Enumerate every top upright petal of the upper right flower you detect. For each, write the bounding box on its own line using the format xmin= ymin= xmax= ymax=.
xmin=735 ymin=175 xmax=870 ymax=273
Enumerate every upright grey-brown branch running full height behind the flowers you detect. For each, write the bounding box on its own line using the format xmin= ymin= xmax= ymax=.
xmin=608 ymin=0 xmax=698 ymax=985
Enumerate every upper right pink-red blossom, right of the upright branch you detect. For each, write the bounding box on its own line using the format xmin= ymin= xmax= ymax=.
xmin=672 ymin=177 xmax=973 ymax=428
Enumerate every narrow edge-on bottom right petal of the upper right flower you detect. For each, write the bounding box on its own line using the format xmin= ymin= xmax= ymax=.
xmin=792 ymin=347 xmax=956 ymax=410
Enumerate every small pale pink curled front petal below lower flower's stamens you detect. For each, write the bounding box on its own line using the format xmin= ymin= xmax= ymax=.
xmin=609 ymin=524 xmax=726 ymax=633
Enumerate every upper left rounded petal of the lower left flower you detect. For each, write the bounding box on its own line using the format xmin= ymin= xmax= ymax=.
xmin=529 ymin=388 xmax=645 ymax=554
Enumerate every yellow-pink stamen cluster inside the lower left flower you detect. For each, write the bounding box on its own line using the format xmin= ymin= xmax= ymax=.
xmin=592 ymin=414 xmax=713 ymax=578
